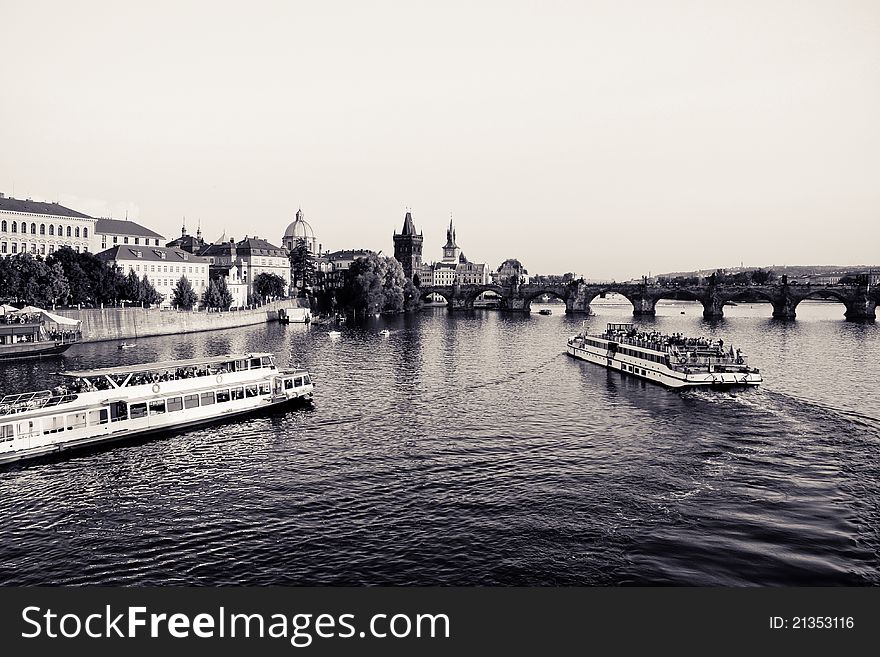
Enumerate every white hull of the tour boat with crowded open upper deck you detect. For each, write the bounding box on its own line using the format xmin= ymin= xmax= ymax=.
xmin=567 ymin=343 xmax=763 ymax=388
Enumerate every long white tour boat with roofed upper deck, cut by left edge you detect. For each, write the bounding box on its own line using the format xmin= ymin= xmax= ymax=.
xmin=0 ymin=353 xmax=314 ymax=463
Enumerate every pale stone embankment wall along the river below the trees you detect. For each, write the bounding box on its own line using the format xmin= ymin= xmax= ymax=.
xmin=54 ymin=299 xmax=309 ymax=342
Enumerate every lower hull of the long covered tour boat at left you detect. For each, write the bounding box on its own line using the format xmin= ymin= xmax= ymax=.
xmin=0 ymin=394 xmax=312 ymax=467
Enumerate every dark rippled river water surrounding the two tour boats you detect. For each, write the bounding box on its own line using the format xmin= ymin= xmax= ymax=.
xmin=0 ymin=299 xmax=880 ymax=586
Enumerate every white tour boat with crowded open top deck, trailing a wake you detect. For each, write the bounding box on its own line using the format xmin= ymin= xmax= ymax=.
xmin=568 ymin=324 xmax=763 ymax=388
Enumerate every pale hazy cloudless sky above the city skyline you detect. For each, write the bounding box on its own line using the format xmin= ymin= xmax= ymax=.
xmin=0 ymin=0 xmax=880 ymax=279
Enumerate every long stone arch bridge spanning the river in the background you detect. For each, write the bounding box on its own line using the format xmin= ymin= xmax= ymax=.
xmin=420 ymin=281 xmax=880 ymax=320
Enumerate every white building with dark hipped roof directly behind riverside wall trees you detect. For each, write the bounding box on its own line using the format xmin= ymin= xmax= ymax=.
xmin=98 ymin=244 xmax=210 ymax=307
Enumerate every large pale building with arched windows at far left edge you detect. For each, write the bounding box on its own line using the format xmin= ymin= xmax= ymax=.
xmin=0 ymin=194 xmax=97 ymax=257
